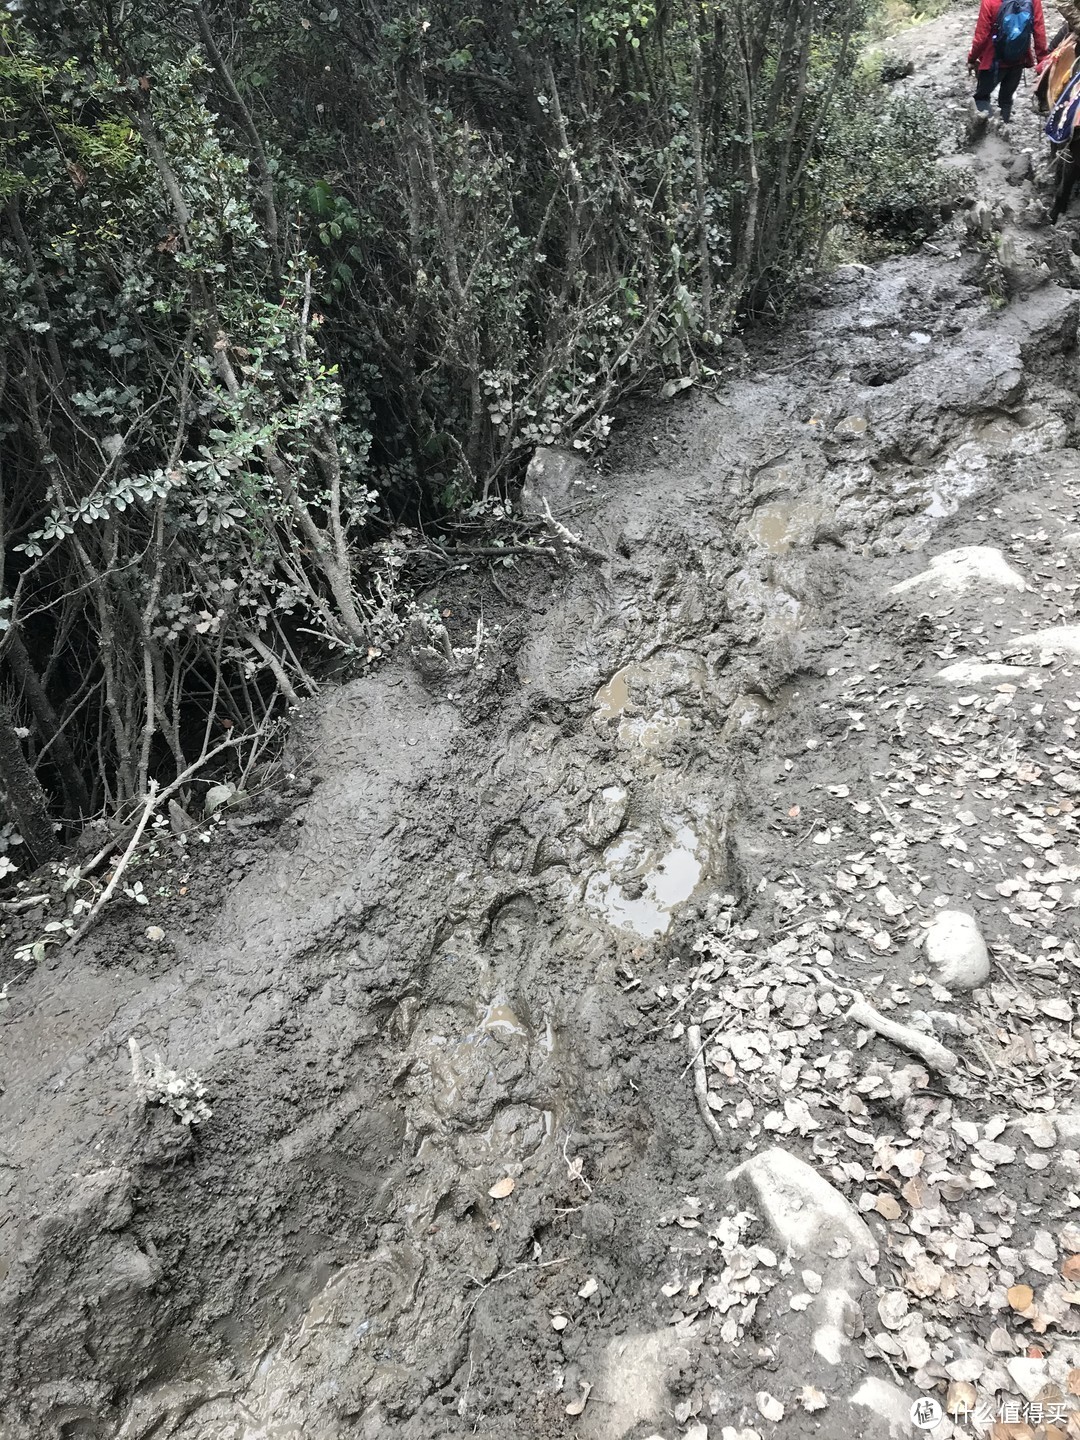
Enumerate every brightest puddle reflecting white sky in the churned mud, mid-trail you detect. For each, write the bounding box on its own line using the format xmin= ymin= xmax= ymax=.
xmin=585 ymin=825 xmax=706 ymax=939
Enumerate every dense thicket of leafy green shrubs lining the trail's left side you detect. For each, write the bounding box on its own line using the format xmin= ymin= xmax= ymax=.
xmin=0 ymin=0 xmax=929 ymax=834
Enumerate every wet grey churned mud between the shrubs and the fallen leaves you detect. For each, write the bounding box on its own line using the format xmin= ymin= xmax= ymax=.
xmin=0 ymin=10 xmax=1080 ymax=1440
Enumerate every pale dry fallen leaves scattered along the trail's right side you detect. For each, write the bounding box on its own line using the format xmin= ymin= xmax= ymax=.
xmin=657 ymin=498 xmax=1080 ymax=1440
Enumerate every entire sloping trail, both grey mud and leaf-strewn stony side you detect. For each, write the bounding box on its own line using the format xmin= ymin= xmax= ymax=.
xmin=0 ymin=7 xmax=1080 ymax=1440
